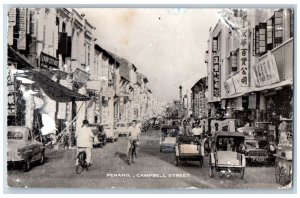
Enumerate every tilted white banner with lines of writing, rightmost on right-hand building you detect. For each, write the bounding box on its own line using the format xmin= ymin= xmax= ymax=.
xmin=252 ymin=52 xmax=280 ymax=86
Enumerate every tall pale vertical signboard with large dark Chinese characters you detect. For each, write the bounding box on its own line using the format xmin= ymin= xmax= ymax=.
xmin=239 ymin=28 xmax=249 ymax=87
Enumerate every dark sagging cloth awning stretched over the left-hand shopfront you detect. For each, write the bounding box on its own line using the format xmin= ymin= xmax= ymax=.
xmin=29 ymin=70 xmax=90 ymax=102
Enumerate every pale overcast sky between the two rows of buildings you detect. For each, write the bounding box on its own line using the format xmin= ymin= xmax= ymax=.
xmin=77 ymin=8 xmax=219 ymax=101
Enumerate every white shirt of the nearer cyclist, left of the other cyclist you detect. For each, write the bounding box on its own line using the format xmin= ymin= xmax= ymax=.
xmin=76 ymin=126 xmax=94 ymax=148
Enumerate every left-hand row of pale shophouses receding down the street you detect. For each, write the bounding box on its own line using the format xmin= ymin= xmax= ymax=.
xmin=7 ymin=8 xmax=159 ymax=141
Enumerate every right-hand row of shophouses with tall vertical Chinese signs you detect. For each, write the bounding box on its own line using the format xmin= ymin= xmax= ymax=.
xmin=186 ymin=8 xmax=294 ymax=135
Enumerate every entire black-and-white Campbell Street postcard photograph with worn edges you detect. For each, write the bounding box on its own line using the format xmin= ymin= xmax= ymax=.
xmin=3 ymin=5 xmax=296 ymax=193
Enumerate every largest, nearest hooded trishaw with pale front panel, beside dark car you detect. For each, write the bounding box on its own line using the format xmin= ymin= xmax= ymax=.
xmin=209 ymin=131 xmax=246 ymax=179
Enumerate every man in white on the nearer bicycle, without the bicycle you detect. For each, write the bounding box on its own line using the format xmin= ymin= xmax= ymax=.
xmin=75 ymin=120 xmax=94 ymax=166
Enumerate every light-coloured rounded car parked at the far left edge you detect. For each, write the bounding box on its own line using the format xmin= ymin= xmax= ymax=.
xmin=7 ymin=126 xmax=45 ymax=171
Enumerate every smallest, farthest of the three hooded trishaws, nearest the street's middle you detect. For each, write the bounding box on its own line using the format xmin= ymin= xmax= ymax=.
xmin=159 ymin=125 xmax=179 ymax=152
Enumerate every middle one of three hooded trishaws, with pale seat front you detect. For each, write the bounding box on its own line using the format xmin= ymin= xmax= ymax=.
xmin=175 ymin=135 xmax=204 ymax=167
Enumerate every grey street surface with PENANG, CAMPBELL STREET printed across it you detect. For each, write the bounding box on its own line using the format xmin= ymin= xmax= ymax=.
xmin=8 ymin=131 xmax=280 ymax=189
